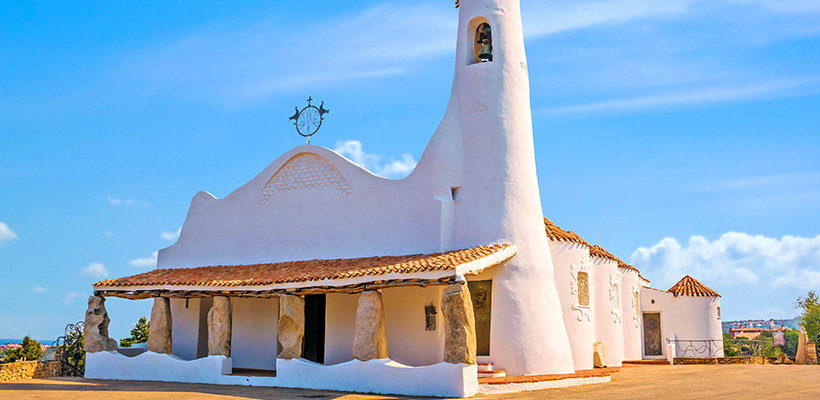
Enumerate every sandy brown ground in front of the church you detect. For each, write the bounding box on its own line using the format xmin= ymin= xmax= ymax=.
xmin=0 ymin=365 xmax=820 ymax=400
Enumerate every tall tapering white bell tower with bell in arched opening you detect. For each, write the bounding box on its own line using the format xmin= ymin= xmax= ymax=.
xmin=448 ymin=0 xmax=574 ymax=375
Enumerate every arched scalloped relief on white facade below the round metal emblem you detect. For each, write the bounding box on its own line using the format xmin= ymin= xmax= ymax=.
xmin=259 ymin=153 xmax=353 ymax=204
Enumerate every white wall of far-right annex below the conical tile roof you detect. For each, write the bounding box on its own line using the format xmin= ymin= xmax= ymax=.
xmin=641 ymin=288 xmax=723 ymax=358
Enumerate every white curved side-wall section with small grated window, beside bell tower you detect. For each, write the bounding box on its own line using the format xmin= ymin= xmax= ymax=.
xmin=549 ymin=241 xmax=596 ymax=371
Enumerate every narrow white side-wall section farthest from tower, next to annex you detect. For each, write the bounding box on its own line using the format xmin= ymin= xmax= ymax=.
xmin=619 ymin=268 xmax=643 ymax=360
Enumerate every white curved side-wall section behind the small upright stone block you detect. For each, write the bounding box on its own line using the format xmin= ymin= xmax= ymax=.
xmin=590 ymin=257 xmax=624 ymax=367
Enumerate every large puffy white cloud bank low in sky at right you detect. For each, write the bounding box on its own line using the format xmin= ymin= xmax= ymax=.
xmin=632 ymin=232 xmax=820 ymax=290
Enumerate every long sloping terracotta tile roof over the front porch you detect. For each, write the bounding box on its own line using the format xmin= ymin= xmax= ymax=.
xmin=94 ymin=244 xmax=511 ymax=287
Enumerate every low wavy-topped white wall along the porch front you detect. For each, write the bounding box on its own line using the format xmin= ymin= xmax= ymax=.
xmin=85 ymin=352 xmax=478 ymax=397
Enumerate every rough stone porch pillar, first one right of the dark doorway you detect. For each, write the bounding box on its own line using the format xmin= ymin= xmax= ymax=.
xmin=353 ymin=290 xmax=388 ymax=361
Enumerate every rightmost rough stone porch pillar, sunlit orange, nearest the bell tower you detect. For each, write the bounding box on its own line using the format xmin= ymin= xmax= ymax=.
xmin=441 ymin=283 xmax=476 ymax=364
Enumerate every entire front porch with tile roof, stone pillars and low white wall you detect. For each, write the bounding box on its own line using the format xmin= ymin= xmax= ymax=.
xmin=85 ymin=244 xmax=516 ymax=397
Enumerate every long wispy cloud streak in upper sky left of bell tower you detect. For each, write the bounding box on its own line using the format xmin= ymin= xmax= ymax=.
xmin=128 ymin=3 xmax=457 ymax=101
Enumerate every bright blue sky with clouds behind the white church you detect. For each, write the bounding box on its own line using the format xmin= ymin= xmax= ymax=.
xmin=0 ymin=0 xmax=820 ymax=339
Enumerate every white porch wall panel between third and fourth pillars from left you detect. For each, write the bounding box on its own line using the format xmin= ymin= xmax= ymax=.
xmin=231 ymin=297 xmax=279 ymax=370
